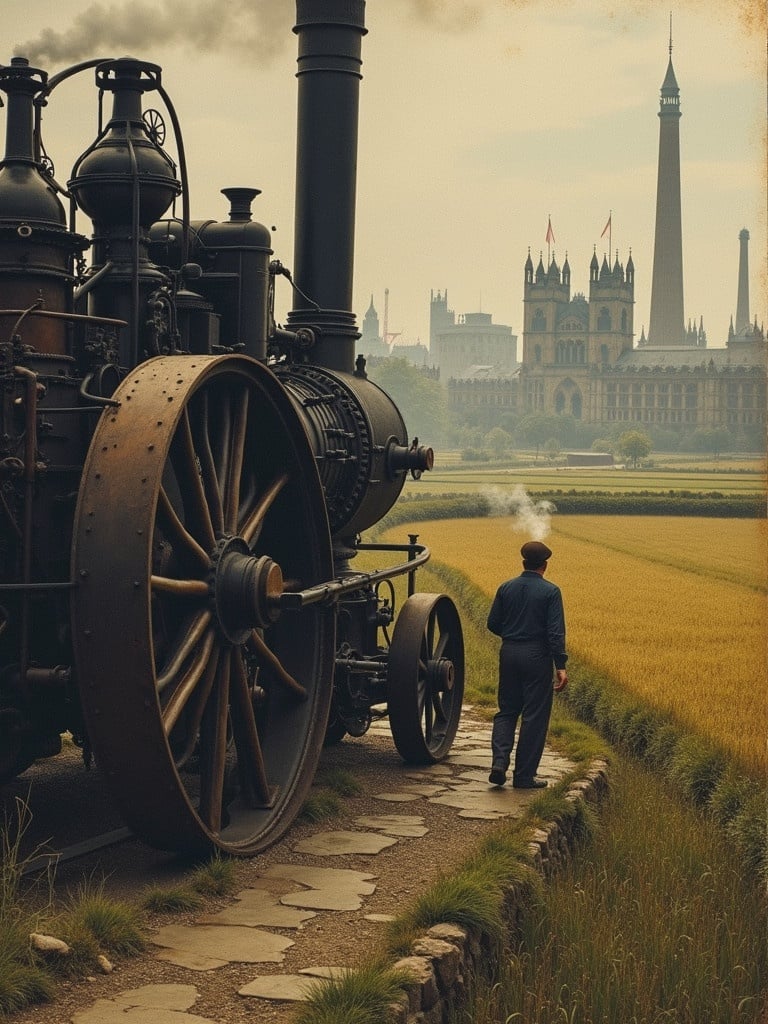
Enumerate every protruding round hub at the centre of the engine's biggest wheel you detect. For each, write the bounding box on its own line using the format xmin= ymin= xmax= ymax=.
xmin=213 ymin=537 xmax=283 ymax=644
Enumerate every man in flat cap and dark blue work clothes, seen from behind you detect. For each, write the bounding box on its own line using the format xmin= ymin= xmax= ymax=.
xmin=487 ymin=541 xmax=568 ymax=790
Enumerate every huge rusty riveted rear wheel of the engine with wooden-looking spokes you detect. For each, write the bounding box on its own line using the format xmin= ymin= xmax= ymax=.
xmin=73 ymin=355 xmax=335 ymax=854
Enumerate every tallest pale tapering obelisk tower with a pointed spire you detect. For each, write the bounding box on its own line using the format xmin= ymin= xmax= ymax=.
xmin=648 ymin=28 xmax=687 ymax=346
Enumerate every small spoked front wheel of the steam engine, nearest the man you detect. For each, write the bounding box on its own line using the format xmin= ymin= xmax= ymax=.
xmin=387 ymin=594 xmax=464 ymax=764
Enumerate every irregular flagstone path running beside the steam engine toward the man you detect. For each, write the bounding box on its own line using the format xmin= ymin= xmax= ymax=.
xmin=70 ymin=715 xmax=572 ymax=1024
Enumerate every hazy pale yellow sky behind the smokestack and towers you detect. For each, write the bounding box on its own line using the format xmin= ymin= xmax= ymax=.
xmin=6 ymin=0 xmax=768 ymax=347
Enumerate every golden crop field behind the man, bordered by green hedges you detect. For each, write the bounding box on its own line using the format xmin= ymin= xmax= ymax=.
xmin=385 ymin=516 xmax=768 ymax=771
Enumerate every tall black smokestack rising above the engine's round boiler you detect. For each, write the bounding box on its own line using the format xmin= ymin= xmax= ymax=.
xmin=288 ymin=0 xmax=366 ymax=373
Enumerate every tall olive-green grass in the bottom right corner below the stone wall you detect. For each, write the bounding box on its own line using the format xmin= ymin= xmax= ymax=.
xmin=455 ymin=762 xmax=768 ymax=1024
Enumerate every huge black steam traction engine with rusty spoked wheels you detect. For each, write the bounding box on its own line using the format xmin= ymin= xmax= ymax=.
xmin=0 ymin=0 xmax=464 ymax=854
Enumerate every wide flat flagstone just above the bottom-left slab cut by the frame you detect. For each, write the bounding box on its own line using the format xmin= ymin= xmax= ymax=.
xmin=152 ymin=925 xmax=294 ymax=970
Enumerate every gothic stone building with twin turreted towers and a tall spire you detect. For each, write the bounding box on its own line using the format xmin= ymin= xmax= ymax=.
xmin=518 ymin=43 xmax=766 ymax=437
